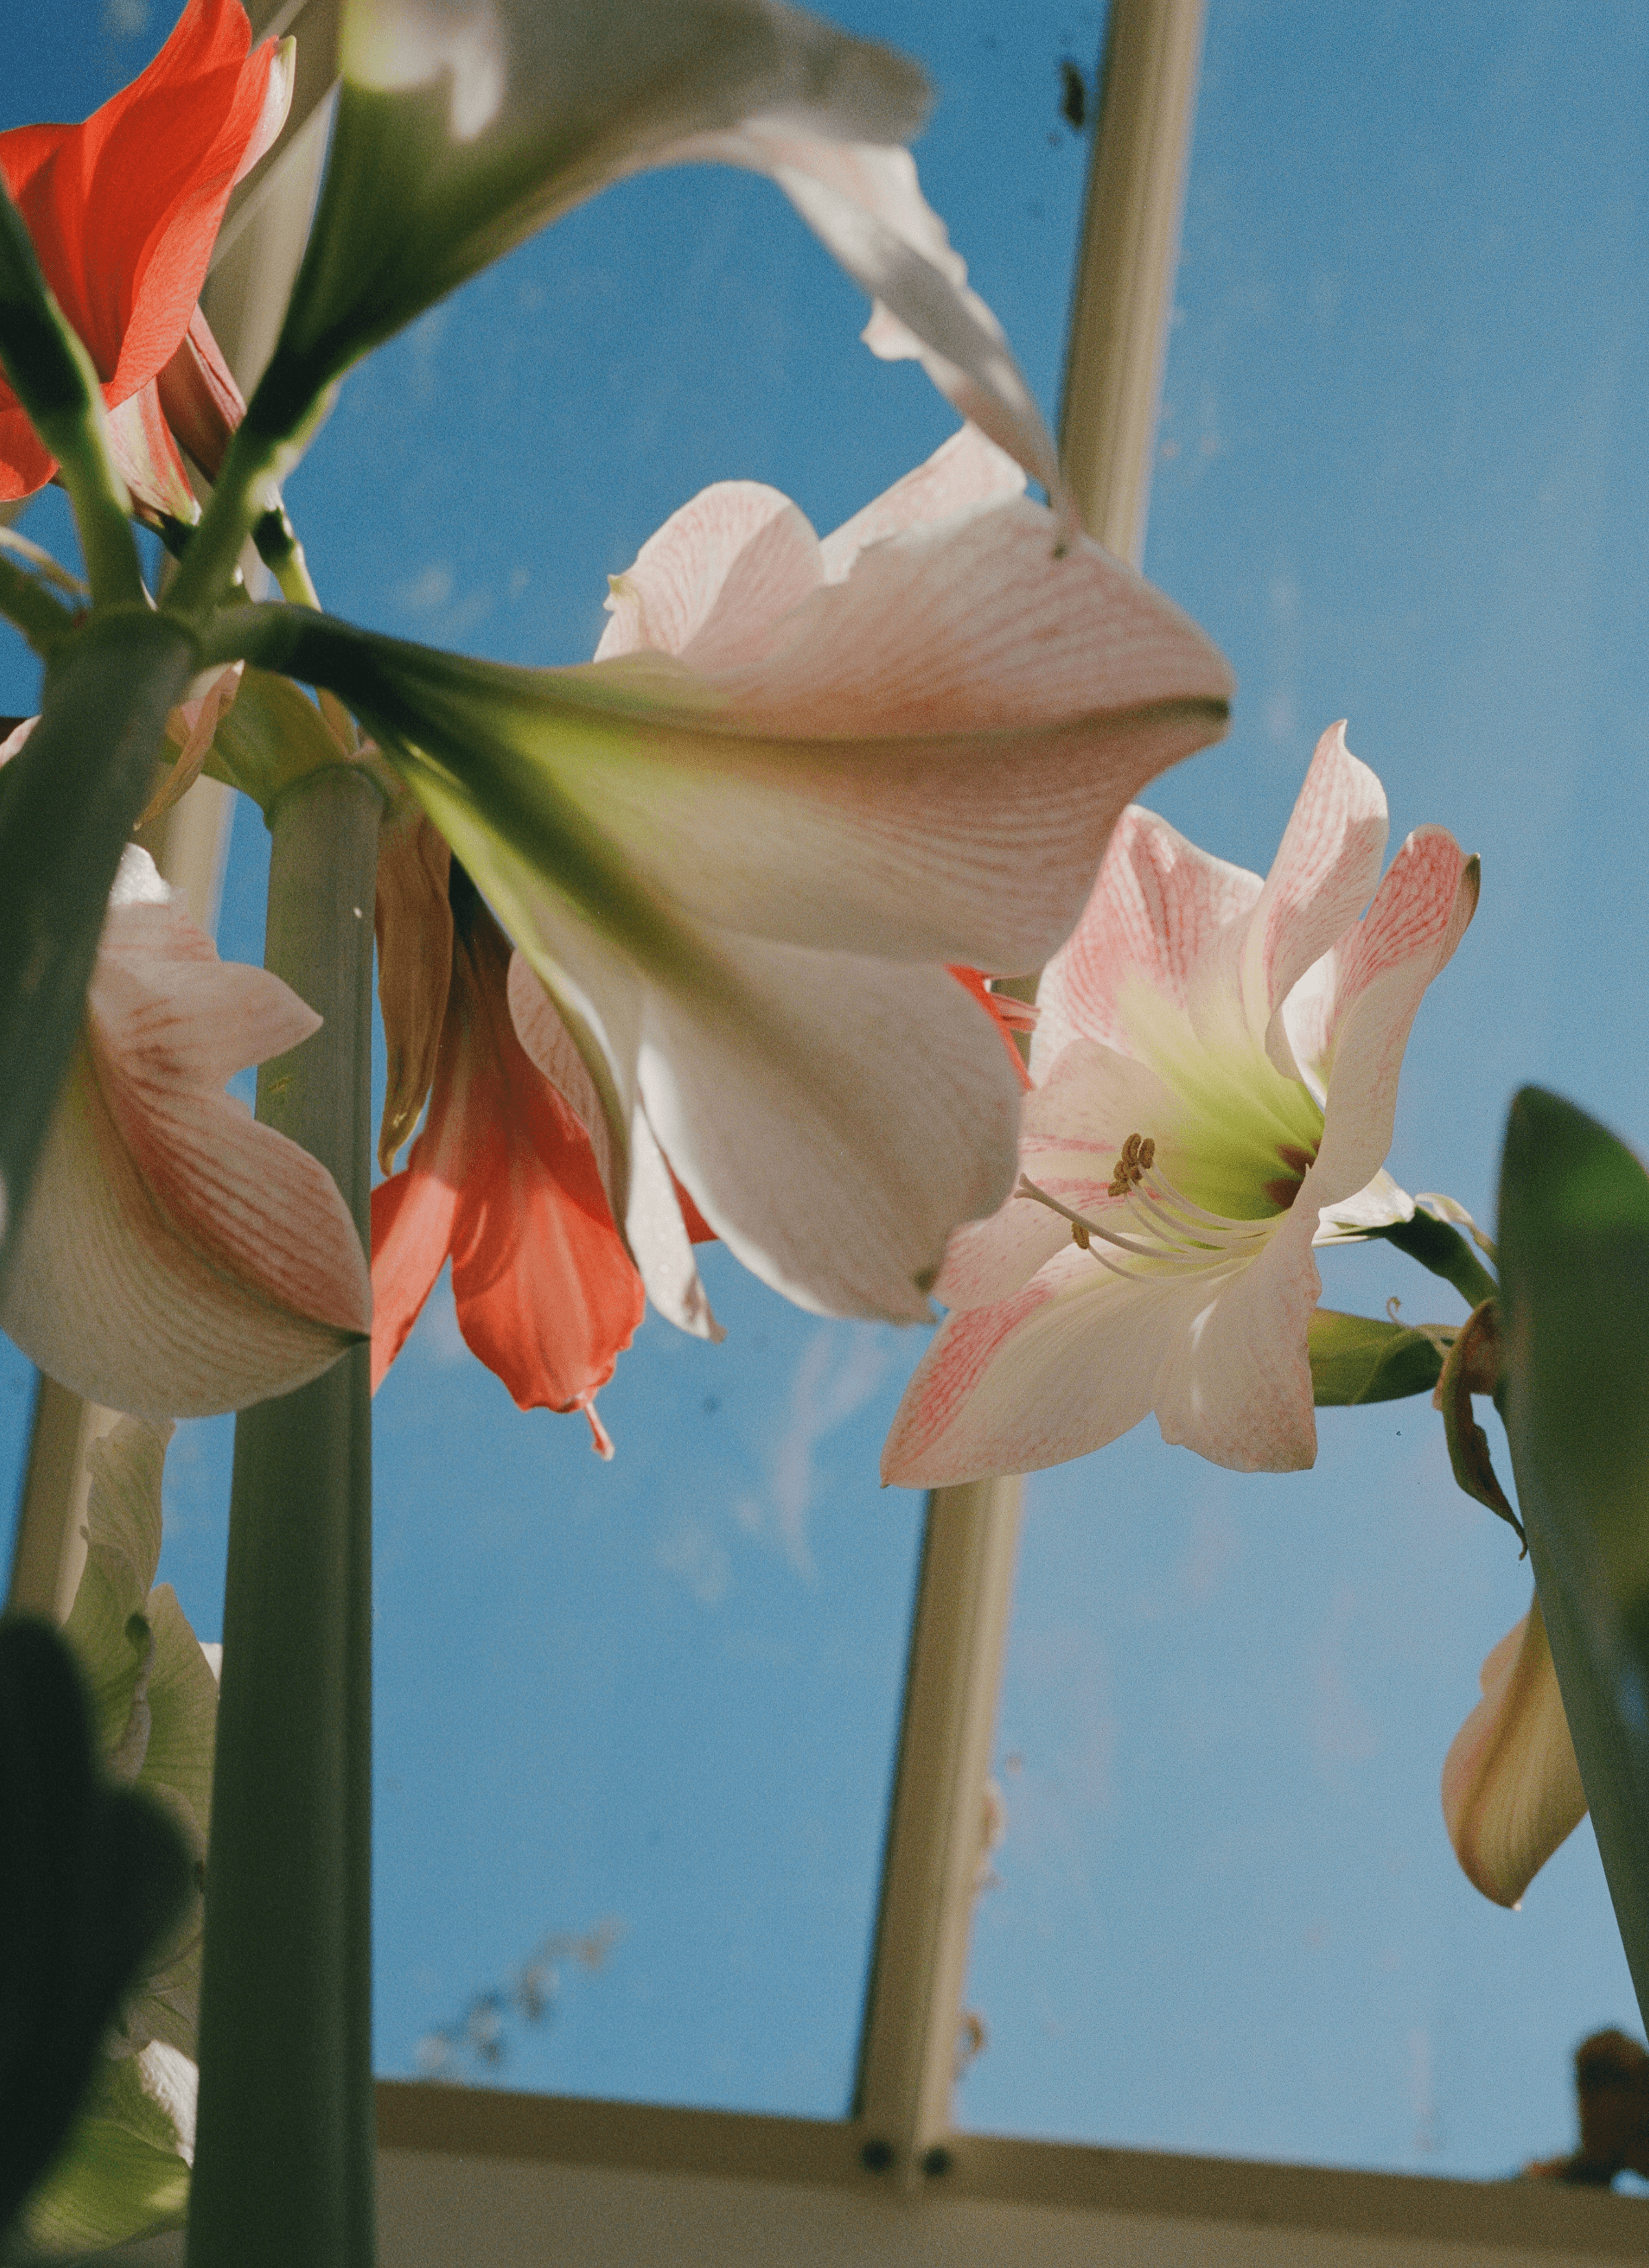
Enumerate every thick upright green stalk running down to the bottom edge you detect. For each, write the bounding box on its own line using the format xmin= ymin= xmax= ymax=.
xmin=188 ymin=766 xmax=381 ymax=2268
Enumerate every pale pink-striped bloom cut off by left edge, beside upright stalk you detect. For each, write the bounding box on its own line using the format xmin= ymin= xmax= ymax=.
xmin=0 ymin=735 xmax=372 ymax=1420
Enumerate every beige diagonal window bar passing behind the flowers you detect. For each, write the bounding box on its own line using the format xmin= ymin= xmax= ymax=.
xmin=853 ymin=0 xmax=1202 ymax=2191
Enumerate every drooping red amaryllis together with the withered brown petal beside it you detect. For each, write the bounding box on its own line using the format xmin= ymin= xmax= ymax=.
xmin=372 ymin=821 xmax=647 ymax=1456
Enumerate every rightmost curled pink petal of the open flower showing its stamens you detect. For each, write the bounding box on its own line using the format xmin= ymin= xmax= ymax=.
xmin=1300 ymin=828 xmax=1477 ymax=1207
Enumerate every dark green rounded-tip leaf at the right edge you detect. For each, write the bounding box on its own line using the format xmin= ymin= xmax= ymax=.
xmin=1499 ymin=1087 xmax=1649 ymax=2014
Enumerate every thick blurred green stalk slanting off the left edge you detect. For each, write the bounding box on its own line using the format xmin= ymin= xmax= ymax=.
xmin=0 ymin=608 xmax=200 ymax=1265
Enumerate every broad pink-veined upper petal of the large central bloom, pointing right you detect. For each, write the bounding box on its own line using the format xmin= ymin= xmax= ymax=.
xmin=560 ymin=501 xmax=1229 ymax=970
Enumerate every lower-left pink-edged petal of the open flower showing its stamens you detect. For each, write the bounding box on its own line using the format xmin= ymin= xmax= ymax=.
xmin=882 ymin=1245 xmax=1207 ymax=1488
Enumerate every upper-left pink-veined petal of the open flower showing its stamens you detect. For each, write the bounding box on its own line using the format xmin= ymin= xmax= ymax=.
xmin=1030 ymin=805 xmax=1261 ymax=1078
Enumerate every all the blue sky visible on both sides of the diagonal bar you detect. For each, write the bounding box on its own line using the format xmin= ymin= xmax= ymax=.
xmin=0 ymin=0 xmax=1649 ymax=2172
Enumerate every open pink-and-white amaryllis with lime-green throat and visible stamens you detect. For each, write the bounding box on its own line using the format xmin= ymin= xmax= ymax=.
xmin=882 ymin=726 xmax=1477 ymax=1488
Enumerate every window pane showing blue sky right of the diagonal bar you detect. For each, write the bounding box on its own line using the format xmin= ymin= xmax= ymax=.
xmin=962 ymin=0 xmax=1649 ymax=2175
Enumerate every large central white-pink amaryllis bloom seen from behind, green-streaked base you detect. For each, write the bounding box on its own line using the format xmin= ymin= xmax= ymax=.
xmin=330 ymin=429 xmax=1232 ymax=1331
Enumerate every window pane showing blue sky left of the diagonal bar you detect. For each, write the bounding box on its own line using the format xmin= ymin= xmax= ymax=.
xmin=0 ymin=0 xmax=1098 ymax=2116
